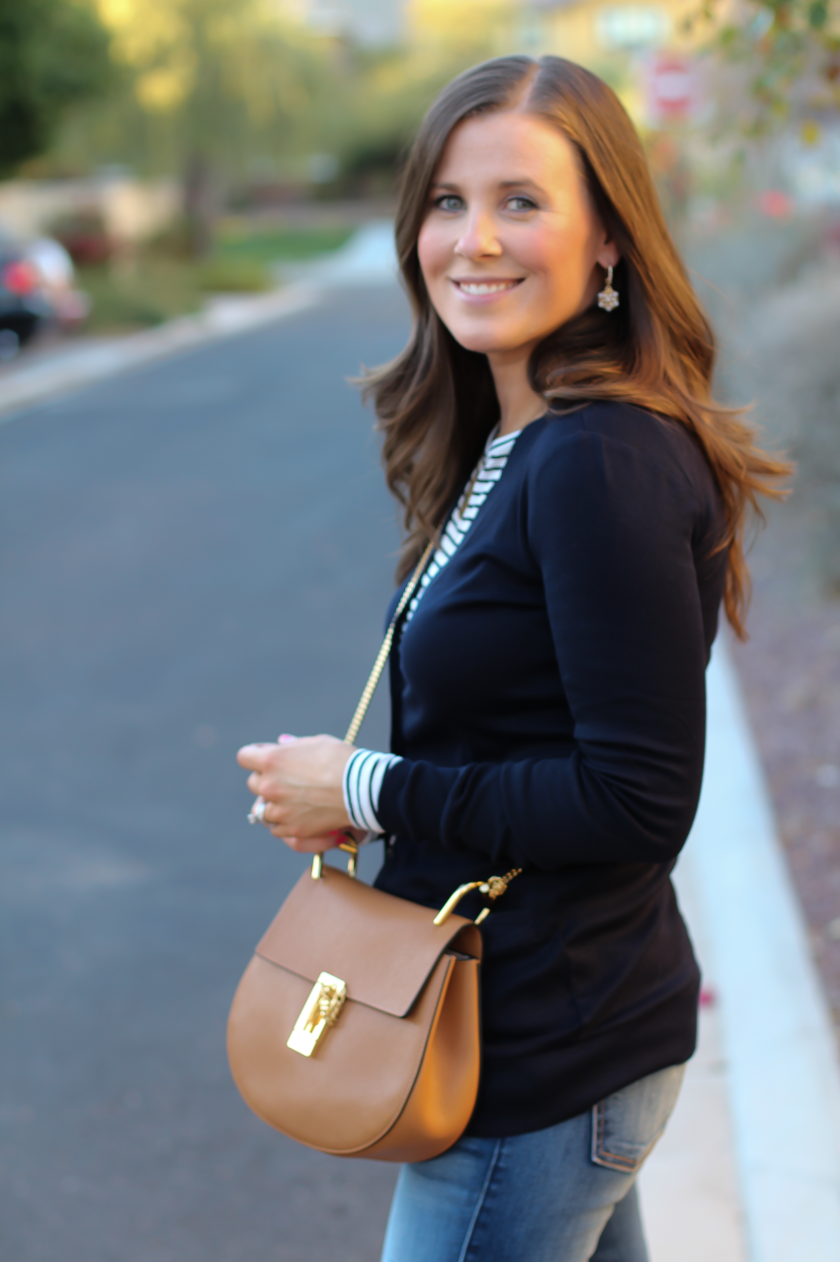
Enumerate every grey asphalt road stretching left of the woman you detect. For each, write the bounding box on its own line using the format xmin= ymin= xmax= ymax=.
xmin=0 ymin=288 xmax=407 ymax=1262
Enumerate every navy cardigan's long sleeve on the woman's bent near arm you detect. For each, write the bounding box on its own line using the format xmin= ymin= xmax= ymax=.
xmin=376 ymin=422 xmax=708 ymax=871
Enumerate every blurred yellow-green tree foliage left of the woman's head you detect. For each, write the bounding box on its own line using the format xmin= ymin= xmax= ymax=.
xmin=52 ymin=0 xmax=492 ymax=190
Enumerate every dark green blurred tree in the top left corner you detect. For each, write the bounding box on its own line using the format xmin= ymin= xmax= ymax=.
xmin=0 ymin=0 xmax=112 ymax=177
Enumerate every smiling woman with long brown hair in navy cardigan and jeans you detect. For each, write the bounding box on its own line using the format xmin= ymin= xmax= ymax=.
xmin=240 ymin=57 xmax=786 ymax=1262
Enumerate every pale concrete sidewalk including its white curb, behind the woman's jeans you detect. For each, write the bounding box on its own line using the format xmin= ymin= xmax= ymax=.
xmin=641 ymin=642 xmax=840 ymax=1262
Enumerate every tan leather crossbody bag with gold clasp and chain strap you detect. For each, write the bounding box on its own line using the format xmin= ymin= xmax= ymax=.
xmin=227 ymin=544 xmax=520 ymax=1161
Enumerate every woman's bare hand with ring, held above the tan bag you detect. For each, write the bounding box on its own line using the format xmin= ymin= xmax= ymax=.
xmin=236 ymin=736 xmax=354 ymax=854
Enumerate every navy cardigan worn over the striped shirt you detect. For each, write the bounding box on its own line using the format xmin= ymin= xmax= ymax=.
xmin=376 ymin=403 xmax=726 ymax=1137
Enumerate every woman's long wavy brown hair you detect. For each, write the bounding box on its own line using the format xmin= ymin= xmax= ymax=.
xmin=363 ymin=57 xmax=791 ymax=639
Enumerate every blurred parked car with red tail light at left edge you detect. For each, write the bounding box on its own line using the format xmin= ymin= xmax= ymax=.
xmin=0 ymin=236 xmax=90 ymax=360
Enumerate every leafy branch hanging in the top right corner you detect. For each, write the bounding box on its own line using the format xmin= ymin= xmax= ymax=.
xmin=686 ymin=0 xmax=840 ymax=140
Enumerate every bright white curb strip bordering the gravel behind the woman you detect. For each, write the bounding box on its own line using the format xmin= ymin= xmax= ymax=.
xmin=681 ymin=641 xmax=840 ymax=1262
